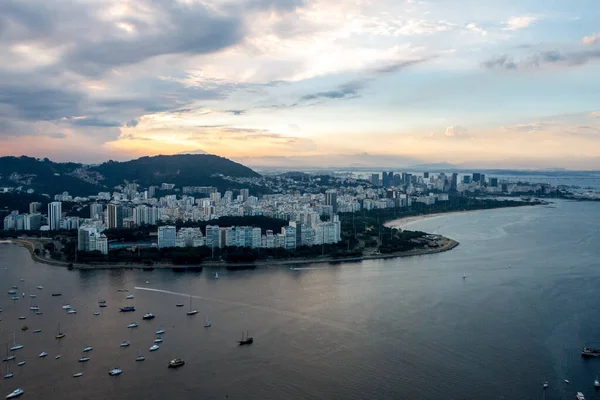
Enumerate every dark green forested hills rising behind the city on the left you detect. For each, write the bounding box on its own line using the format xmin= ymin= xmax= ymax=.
xmin=0 ymin=154 xmax=259 ymax=196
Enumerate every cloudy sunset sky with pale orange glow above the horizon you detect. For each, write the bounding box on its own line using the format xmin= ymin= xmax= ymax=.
xmin=0 ymin=0 xmax=600 ymax=169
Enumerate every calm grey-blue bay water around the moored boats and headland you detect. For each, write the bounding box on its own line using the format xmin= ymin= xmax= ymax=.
xmin=0 ymin=202 xmax=600 ymax=400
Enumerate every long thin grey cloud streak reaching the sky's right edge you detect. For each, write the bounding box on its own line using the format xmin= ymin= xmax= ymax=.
xmin=483 ymin=49 xmax=600 ymax=71
